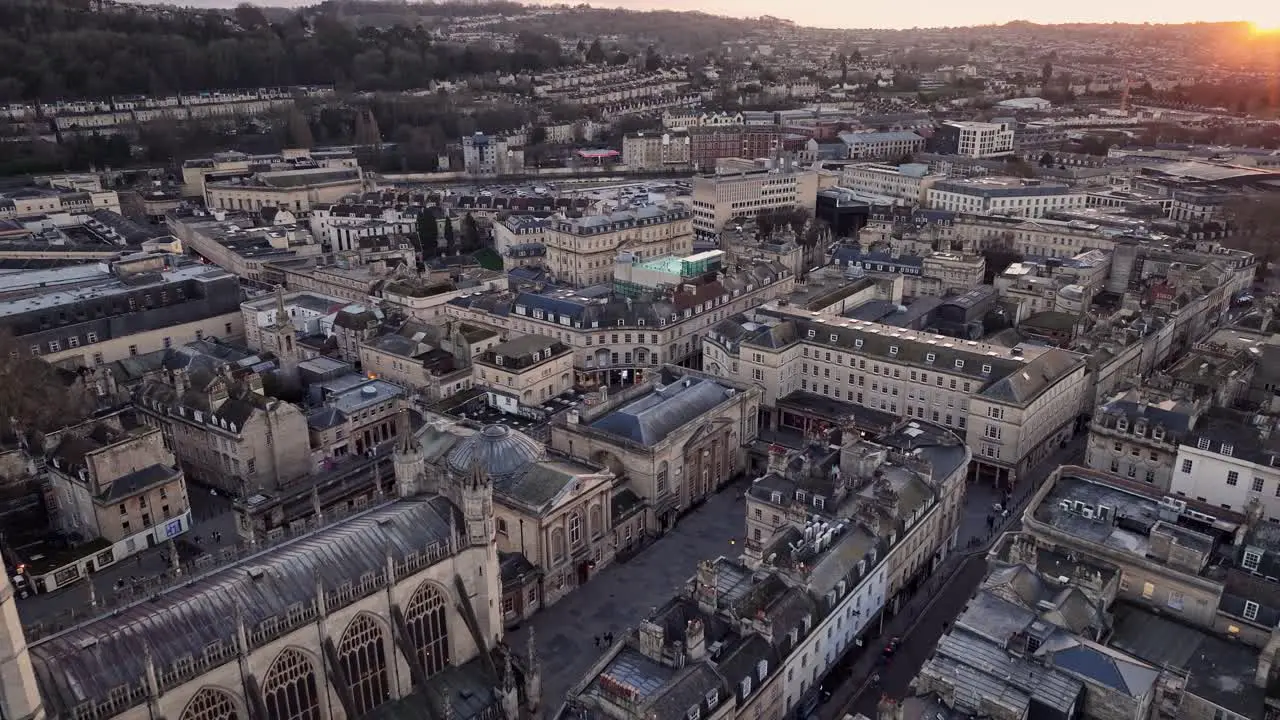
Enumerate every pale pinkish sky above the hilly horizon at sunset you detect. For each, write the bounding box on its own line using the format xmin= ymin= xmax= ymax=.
xmin=514 ymin=0 xmax=1280 ymax=28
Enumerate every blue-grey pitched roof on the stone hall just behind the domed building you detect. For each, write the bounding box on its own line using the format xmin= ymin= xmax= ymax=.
xmin=591 ymin=377 xmax=735 ymax=447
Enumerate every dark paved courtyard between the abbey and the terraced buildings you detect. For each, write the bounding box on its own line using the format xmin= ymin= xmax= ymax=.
xmin=507 ymin=482 xmax=746 ymax=716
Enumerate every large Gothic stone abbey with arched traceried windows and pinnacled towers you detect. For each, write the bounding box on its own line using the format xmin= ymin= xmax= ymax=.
xmin=0 ymin=413 xmax=540 ymax=720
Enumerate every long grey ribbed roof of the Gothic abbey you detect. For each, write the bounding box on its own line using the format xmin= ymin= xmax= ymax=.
xmin=31 ymin=496 xmax=462 ymax=716
